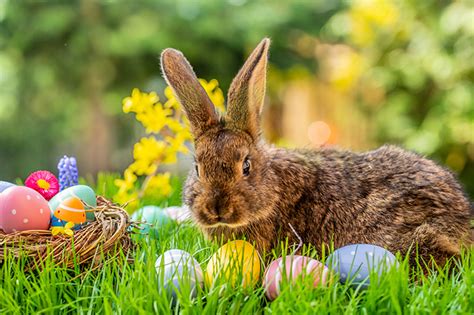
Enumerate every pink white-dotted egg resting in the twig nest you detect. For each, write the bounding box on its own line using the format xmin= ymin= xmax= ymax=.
xmin=0 ymin=186 xmax=51 ymax=233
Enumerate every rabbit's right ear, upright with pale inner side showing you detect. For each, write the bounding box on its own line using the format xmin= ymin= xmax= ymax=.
xmin=226 ymin=38 xmax=270 ymax=140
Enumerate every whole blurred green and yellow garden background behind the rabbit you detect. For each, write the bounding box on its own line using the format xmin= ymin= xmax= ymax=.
xmin=0 ymin=0 xmax=474 ymax=199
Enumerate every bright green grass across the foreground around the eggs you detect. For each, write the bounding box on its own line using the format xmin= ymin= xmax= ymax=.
xmin=0 ymin=179 xmax=474 ymax=314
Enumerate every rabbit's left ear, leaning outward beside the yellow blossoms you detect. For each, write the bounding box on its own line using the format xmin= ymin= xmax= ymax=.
xmin=161 ymin=48 xmax=219 ymax=138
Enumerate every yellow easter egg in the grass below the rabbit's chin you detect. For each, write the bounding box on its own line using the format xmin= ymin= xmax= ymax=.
xmin=205 ymin=240 xmax=260 ymax=287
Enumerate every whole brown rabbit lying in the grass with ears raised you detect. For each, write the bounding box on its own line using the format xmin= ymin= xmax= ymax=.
xmin=161 ymin=39 xmax=470 ymax=263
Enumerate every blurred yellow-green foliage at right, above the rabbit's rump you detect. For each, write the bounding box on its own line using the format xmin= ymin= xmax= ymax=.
xmin=328 ymin=1 xmax=474 ymax=196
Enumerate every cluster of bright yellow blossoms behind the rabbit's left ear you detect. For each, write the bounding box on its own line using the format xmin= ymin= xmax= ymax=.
xmin=114 ymin=79 xmax=225 ymax=210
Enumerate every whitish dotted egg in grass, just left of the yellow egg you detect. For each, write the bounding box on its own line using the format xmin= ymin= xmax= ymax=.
xmin=155 ymin=249 xmax=203 ymax=301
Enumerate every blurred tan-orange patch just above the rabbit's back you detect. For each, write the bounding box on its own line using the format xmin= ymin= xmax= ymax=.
xmin=281 ymin=79 xmax=373 ymax=150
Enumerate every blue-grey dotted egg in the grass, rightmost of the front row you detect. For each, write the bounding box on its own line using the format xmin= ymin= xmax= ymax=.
xmin=326 ymin=244 xmax=396 ymax=287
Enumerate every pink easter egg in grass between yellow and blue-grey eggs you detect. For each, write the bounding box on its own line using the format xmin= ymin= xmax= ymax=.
xmin=263 ymin=255 xmax=330 ymax=300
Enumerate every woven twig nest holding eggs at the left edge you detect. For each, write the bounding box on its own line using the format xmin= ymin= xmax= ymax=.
xmin=0 ymin=196 xmax=134 ymax=268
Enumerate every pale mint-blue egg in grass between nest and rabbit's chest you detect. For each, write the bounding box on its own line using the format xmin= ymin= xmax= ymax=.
xmin=132 ymin=206 xmax=173 ymax=237
